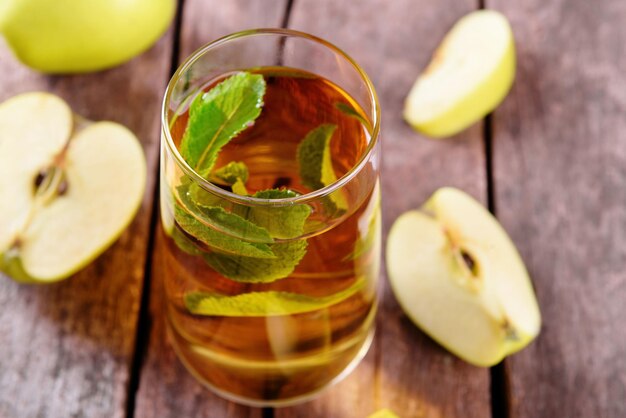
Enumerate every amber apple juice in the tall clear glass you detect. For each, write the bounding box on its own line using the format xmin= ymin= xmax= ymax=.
xmin=162 ymin=67 xmax=381 ymax=405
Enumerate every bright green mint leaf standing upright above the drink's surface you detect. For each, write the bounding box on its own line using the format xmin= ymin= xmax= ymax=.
xmin=180 ymin=72 xmax=265 ymax=178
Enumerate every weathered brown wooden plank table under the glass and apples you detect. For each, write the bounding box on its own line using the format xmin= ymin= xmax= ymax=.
xmin=0 ymin=0 xmax=626 ymax=418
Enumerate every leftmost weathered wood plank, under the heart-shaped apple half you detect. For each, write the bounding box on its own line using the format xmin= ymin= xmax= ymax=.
xmin=0 ymin=23 xmax=172 ymax=418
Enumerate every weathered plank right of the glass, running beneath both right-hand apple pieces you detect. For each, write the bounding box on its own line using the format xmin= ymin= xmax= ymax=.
xmin=276 ymin=0 xmax=490 ymax=418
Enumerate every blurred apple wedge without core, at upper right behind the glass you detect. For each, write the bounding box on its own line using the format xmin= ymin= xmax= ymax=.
xmin=404 ymin=10 xmax=515 ymax=138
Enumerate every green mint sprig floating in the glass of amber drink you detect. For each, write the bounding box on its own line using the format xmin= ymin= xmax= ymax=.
xmin=168 ymin=72 xmax=347 ymax=290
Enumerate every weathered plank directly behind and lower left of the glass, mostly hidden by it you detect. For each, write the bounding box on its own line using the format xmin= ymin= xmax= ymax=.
xmin=135 ymin=0 xmax=287 ymax=418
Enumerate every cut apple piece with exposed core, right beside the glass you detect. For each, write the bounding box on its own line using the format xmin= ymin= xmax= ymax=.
xmin=387 ymin=188 xmax=541 ymax=366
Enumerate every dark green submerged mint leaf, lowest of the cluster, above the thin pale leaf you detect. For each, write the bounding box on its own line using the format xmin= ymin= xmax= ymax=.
xmin=204 ymin=240 xmax=308 ymax=283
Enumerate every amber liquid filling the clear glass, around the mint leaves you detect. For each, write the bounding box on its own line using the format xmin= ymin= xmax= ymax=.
xmin=158 ymin=68 xmax=380 ymax=405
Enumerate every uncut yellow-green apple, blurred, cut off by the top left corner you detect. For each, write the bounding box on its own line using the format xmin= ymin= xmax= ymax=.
xmin=0 ymin=0 xmax=176 ymax=73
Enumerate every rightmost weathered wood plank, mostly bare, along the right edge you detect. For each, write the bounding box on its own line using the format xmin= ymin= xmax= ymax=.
xmin=488 ymin=0 xmax=626 ymax=417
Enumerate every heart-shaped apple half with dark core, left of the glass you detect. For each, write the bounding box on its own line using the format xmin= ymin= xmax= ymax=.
xmin=0 ymin=93 xmax=146 ymax=282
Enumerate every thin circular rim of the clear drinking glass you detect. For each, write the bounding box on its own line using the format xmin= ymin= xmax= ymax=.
xmin=161 ymin=28 xmax=380 ymax=206
